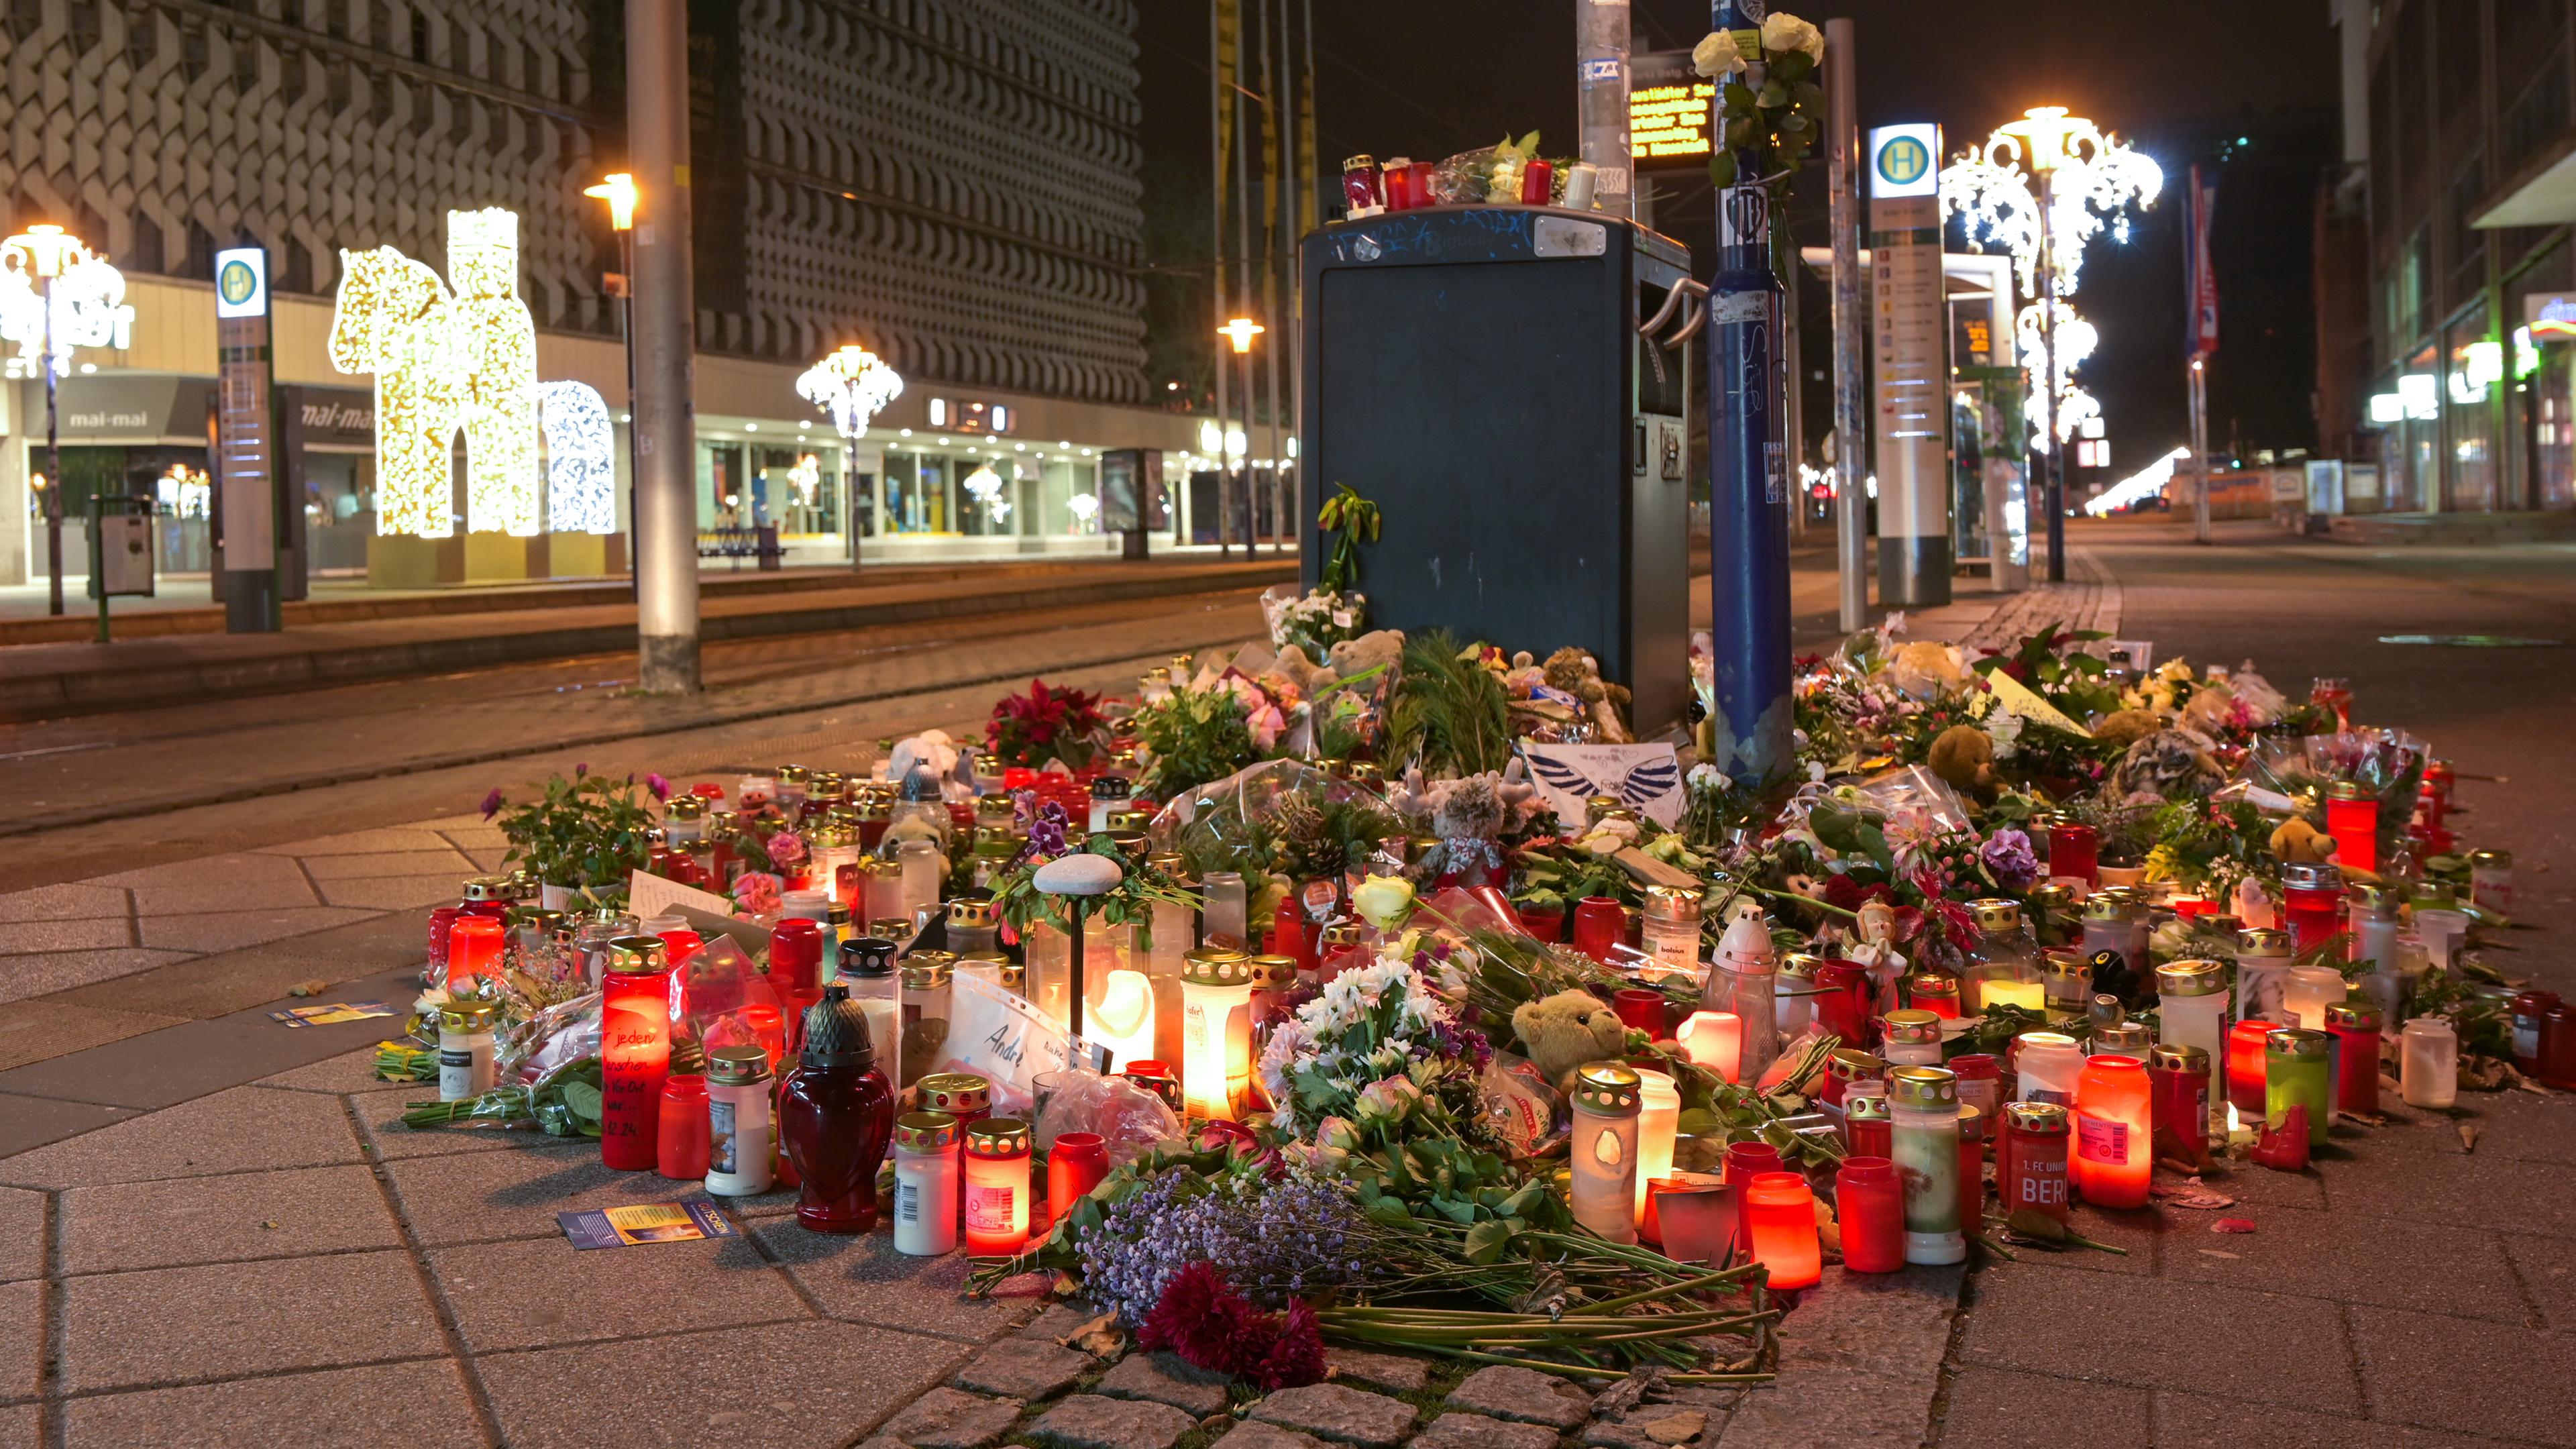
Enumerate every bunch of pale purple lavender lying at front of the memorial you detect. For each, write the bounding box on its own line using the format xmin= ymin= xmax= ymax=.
xmin=1079 ymin=1168 xmax=1365 ymax=1323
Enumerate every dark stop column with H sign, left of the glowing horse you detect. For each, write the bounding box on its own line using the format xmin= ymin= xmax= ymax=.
xmin=214 ymin=248 xmax=281 ymax=634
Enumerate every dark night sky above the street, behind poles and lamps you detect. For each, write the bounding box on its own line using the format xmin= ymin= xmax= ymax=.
xmin=1138 ymin=0 xmax=2339 ymax=474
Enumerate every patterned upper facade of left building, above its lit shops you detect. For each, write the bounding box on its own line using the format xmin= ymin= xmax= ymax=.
xmin=0 ymin=0 xmax=1144 ymax=402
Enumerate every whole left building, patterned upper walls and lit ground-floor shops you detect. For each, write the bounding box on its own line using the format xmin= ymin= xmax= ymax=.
xmin=0 ymin=0 xmax=1193 ymax=578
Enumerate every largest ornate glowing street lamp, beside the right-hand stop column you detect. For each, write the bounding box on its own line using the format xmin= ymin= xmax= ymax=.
xmin=1940 ymin=106 xmax=2164 ymax=580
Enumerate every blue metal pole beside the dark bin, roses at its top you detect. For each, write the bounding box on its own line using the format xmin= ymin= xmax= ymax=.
xmin=1705 ymin=0 xmax=1795 ymax=784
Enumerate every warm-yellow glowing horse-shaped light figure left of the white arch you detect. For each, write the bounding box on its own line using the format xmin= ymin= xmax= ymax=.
xmin=330 ymin=206 xmax=546 ymax=539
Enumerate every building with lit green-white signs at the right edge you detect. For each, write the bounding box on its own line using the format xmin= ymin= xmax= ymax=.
xmin=2316 ymin=0 xmax=2576 ymax=513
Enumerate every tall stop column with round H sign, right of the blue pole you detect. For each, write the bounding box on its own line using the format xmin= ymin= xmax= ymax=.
xmin=1870 ymin=123 xmax=1950 ymax=608
